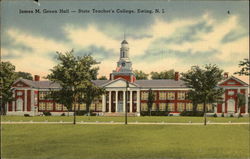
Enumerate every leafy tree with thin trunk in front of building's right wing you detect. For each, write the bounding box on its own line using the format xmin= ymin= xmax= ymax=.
xmin=181 ymin=64 xmax=224 ymax=125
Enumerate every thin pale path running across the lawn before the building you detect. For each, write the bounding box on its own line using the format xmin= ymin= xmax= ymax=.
xmin=1 ymin=121 xmax=250 ymax=125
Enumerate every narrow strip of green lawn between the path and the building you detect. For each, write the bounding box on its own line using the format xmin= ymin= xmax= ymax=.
xmin=2 ymin=116 xmax=249 ymax=123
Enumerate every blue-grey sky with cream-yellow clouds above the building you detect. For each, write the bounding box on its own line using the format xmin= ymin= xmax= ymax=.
xmin=1 ymin=0 xmax=249 ymax=81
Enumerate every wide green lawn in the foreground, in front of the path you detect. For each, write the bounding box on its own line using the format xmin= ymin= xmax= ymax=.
xmin=2 ymin=124 xmax=249 ymax=159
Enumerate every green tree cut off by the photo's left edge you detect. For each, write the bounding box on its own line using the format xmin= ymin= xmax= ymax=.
xmin=0 ymin=62 xmax=16 ymax=115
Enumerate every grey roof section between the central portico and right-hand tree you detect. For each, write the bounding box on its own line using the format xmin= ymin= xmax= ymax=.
xmin=135 ymin=79 xmax=187 ymax=88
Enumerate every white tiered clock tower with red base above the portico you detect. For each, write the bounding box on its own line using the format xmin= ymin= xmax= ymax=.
xmin=110 ymin=39 xmax=136 ymax=82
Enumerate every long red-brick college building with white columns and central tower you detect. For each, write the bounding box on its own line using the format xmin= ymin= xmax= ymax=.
xmin=7 ymin=40 xmax=248 ymax=115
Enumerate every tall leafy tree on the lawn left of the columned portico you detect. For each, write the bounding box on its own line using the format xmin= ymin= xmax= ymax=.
xmin=46 ymin=50 xmax=102 ymax=124
